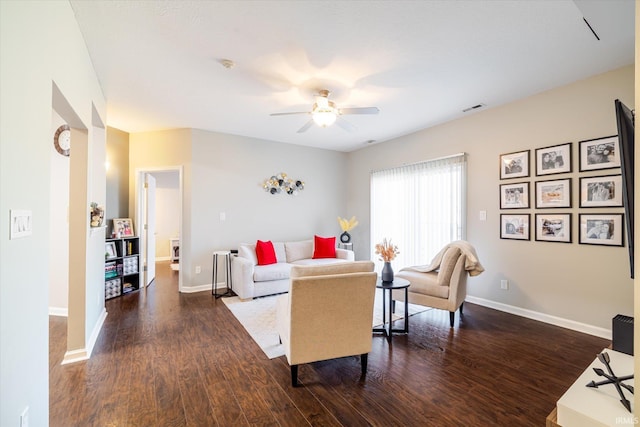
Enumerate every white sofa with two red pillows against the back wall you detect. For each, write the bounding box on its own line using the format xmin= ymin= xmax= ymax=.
xmin=231 ymin=240 xmax=355 ymax=300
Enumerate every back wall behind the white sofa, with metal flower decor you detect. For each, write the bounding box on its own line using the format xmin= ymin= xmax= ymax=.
xmin=130 ymin=130 xmax=347 ymax=292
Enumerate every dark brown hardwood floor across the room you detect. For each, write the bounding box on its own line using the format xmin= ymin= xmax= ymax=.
xmin=49 ymin=262 xmax=610 ymax=427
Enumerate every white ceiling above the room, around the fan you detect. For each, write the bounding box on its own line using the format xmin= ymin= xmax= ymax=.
xmin=71 ymin=0 xmax=634 ymax=151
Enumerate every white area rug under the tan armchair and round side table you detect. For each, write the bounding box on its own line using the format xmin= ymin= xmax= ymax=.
xmin=222 ymin=289 xmax=430 ymax=359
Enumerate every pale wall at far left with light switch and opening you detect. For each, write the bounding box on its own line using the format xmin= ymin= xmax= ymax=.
xmin=0 ymin=1 xmax=106 ymax=426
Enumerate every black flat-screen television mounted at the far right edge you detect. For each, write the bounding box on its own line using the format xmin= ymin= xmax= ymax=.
xmin=615 ymin=99 xmax=635 ymax=279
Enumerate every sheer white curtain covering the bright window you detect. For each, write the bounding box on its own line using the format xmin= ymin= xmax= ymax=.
xmin=371 ymin=153 xmax=467 ymax=271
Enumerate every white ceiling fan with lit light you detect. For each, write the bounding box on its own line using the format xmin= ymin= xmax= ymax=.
xmin=271 ymin=89 xmax=380 ymax=133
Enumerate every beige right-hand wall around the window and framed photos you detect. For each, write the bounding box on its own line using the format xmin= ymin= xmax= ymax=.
xmin=347 ymin=66 xmax=634 ymax=336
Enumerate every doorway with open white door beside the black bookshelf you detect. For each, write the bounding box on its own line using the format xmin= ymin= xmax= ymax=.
xmin=135 ymin=166 xmax=183 ymax=291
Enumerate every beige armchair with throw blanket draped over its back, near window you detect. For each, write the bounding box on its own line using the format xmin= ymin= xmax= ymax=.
xmin=393 ymin=241 xmax=484 ymax=327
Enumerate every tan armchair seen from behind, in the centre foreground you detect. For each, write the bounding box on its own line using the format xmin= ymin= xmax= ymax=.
xmin=276 ymin=261 xmax=377 ymax=387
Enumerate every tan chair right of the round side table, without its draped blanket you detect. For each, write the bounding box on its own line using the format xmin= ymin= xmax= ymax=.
xmin=393 ymin=247 xmax=467 ymax=327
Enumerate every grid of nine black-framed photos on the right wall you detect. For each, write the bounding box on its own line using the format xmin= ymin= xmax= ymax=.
xmin=499 ymin=135 xmax=624 ymax=246
